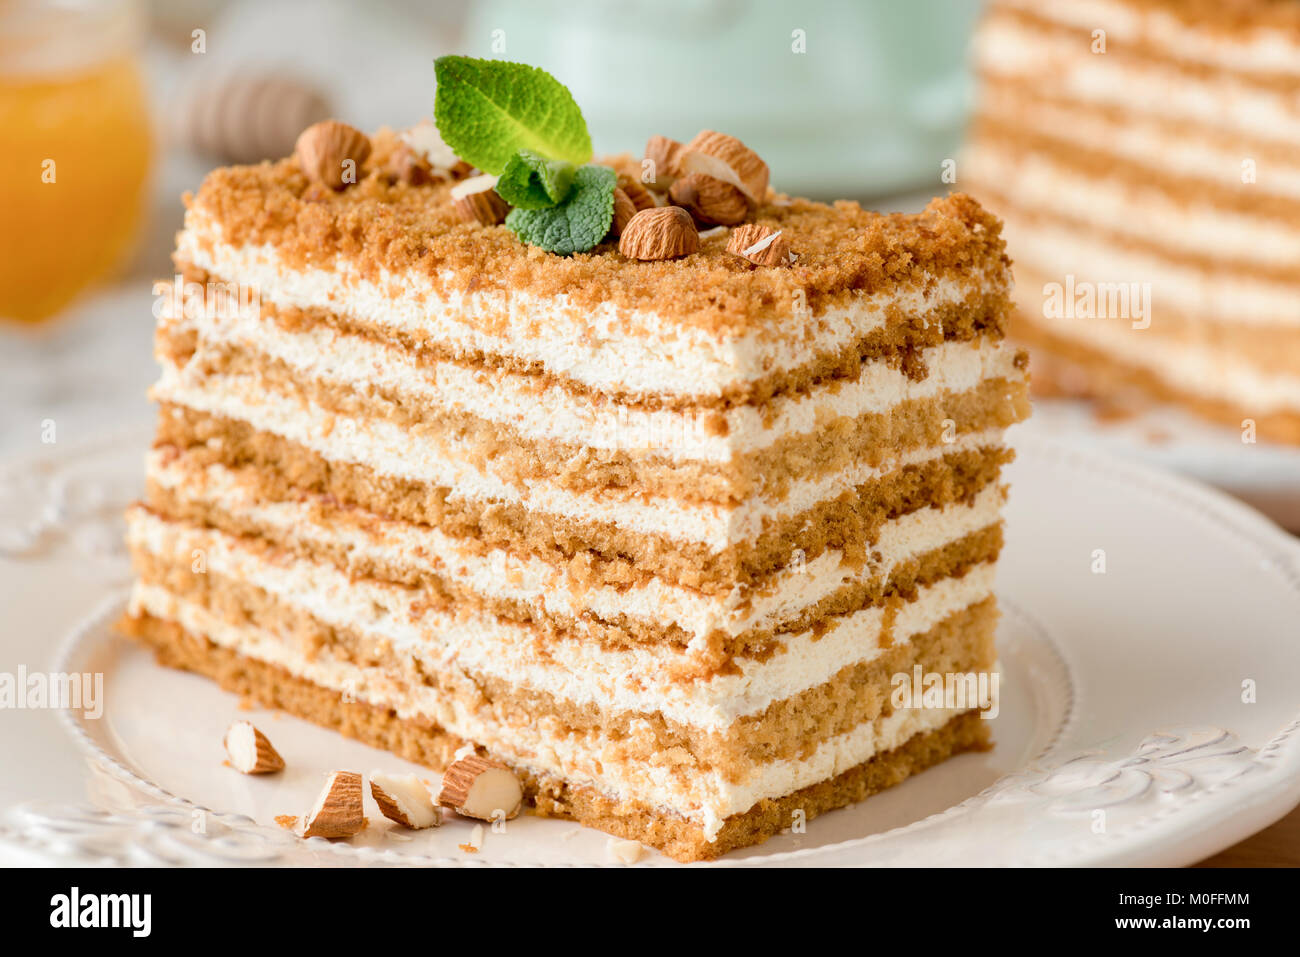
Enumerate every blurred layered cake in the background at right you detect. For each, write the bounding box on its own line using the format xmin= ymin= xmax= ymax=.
xmin=958 ymin=0 xmax=1300 ymax=442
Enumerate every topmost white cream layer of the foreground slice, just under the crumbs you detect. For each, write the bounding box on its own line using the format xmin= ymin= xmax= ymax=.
xmin=177 ymin=218 xmax=1008 ymax=397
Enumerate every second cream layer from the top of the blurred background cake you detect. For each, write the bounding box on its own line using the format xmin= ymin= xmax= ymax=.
xmin=974 ymin=11 xmax=1300 ymax=143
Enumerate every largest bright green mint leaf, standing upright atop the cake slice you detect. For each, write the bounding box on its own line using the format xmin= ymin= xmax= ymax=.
xmin=433 ymin=56 xmax=592 ymax=176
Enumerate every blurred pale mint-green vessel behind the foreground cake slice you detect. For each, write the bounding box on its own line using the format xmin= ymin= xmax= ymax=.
xmin=462 ymin=0 xmax=980 ymax=199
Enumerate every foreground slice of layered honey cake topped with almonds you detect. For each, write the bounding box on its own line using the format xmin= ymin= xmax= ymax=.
xmin=125 ymin=61 xmax=1027 ymax=859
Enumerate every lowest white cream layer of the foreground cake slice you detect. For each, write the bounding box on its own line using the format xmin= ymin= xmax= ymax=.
xmin=131 ymin=585 xmax=961 ymax=840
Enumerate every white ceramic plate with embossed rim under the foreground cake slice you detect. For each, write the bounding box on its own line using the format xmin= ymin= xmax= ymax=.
xmin=0 ymin=432 xmax=1300 ymax=866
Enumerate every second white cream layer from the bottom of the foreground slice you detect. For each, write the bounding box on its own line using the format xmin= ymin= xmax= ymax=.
xmin=127 ymin=510 xmax=993 ymax=731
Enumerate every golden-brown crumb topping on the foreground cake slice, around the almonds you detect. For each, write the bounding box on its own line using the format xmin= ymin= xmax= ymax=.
xmin=186 ymin=130 xmax=1010 ymax=334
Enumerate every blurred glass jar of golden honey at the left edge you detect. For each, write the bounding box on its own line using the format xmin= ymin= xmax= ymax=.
xmin=0 ymin=1 xmax=151 ymax=321
